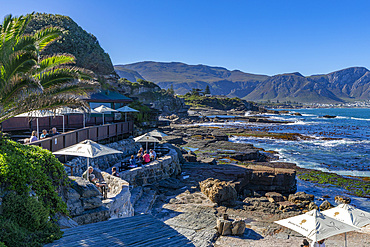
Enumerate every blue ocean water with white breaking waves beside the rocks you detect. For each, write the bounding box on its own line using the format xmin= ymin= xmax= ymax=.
xmin=195 ymin=108 xmax=370 ymax=211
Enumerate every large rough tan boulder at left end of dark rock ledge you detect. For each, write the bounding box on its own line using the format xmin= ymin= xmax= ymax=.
xmin=199 ymin=178 xmax=238 ymax=204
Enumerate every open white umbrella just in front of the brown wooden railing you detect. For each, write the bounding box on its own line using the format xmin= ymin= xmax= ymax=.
xmin=53 ymin=140 xmax=122 ymax=180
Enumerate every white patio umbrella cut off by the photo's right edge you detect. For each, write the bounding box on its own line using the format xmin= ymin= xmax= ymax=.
xmin=322 ymin=204 xmax=370 ymax=246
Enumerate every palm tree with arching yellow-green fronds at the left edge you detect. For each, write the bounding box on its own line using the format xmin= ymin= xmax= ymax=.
xmin=0 ymin=13 xmax=96 ymax=123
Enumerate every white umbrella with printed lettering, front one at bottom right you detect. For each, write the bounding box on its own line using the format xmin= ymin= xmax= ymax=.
xmin=275 ymin=209 xmax=358 ymax=246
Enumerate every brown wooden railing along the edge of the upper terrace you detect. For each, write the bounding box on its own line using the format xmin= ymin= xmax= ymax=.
xmin=28 ymin=121 xmax=134 ymax=152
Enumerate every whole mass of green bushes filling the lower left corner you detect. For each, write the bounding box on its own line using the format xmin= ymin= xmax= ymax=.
xmin=0 ymin=138 xmax=67 ymax=246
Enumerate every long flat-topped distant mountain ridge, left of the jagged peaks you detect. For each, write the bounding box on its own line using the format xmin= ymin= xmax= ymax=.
xmin=114 ymin=62 xmax=268 ymax=97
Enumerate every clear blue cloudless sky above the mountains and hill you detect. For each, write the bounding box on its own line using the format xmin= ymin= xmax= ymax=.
xmin=0 ymin=0 xmax=370 ymax=75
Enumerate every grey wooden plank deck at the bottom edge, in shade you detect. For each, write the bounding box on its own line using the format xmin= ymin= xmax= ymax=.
xmin=45 ymin=215 xmax=194 ymax=247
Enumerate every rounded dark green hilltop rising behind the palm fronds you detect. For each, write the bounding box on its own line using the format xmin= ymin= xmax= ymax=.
xmin=26 ymin=13 xmax=114 ymax=75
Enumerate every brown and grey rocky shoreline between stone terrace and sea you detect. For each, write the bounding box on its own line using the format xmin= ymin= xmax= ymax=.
xmin=146 ymin=110 xmax=370 ymax=246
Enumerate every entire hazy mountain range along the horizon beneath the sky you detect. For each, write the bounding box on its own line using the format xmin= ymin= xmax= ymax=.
xmin=114 ymin=61 xmax=370 ymax=103
